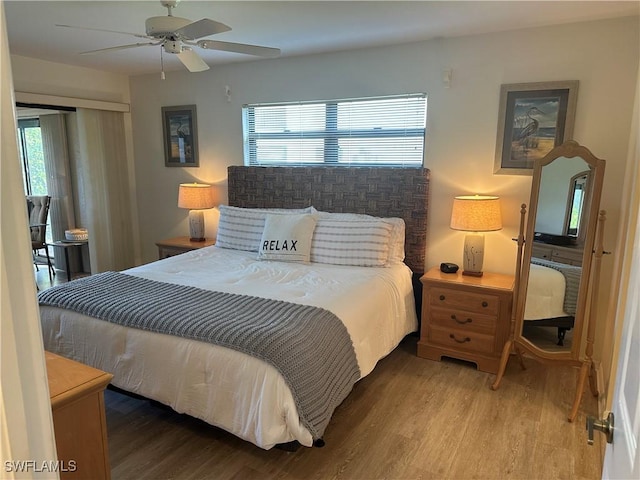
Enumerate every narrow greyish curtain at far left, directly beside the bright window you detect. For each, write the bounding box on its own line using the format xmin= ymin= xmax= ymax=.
xmin=40 ymin=114 xmax=75 ymax=270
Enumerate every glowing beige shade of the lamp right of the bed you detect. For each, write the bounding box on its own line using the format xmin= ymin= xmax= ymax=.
xmin=450 ymin=195 xmax=502 ymax=232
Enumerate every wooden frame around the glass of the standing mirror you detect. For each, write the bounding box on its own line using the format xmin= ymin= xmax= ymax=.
xmin=514 ymin=140 xmax=605 ymax=363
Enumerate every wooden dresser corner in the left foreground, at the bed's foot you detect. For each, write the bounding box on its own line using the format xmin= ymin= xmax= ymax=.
xmin=45 ymin=352 xmax=113 ymax=480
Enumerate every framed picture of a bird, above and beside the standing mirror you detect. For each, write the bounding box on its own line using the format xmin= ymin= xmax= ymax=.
xmin=493 ymin=80 xmax=578 ymax=175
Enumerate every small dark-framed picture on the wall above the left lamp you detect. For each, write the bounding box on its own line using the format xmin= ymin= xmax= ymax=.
xmin=162 ymin=105 xmax=198 ymax=167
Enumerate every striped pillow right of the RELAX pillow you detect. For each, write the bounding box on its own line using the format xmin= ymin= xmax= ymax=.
xmin=311 ymin=217 xmax=393 ymax=267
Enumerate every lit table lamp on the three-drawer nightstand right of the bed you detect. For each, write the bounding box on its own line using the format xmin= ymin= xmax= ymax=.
xmin=450 ymin=195 xmax=502 ymax=277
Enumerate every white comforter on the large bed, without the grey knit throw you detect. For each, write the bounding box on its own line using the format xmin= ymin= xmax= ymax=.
xmin=41 ymin=247 xmax=417 ymax=449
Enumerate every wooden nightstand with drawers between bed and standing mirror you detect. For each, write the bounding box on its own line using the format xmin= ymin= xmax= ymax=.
xmin=418 ymin=267 xmax=514 ymax=373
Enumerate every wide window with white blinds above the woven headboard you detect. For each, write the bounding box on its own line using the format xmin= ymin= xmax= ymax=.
xmin=242 ymin=93 xmax=427 ymax=167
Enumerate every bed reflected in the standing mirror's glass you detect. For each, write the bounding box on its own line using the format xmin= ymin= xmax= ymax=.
xmin=524 ymin=257 xmax=582 ymax=346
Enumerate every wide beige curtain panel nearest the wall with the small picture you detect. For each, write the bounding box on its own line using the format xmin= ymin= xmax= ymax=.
xmin=67 ymin=108 xmax=134 ymax=273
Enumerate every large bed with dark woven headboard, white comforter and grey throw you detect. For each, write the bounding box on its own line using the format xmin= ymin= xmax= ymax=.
xmin=41 ymin=167 xmax=429 ymax=449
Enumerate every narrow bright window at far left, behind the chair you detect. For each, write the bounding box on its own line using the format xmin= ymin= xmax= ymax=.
xmin=18 ymin=118 xmax=47 ymax=195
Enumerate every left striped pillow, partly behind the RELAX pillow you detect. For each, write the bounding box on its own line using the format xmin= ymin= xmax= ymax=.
xmin=216 ymin=205 xmax=316 ymax=252
